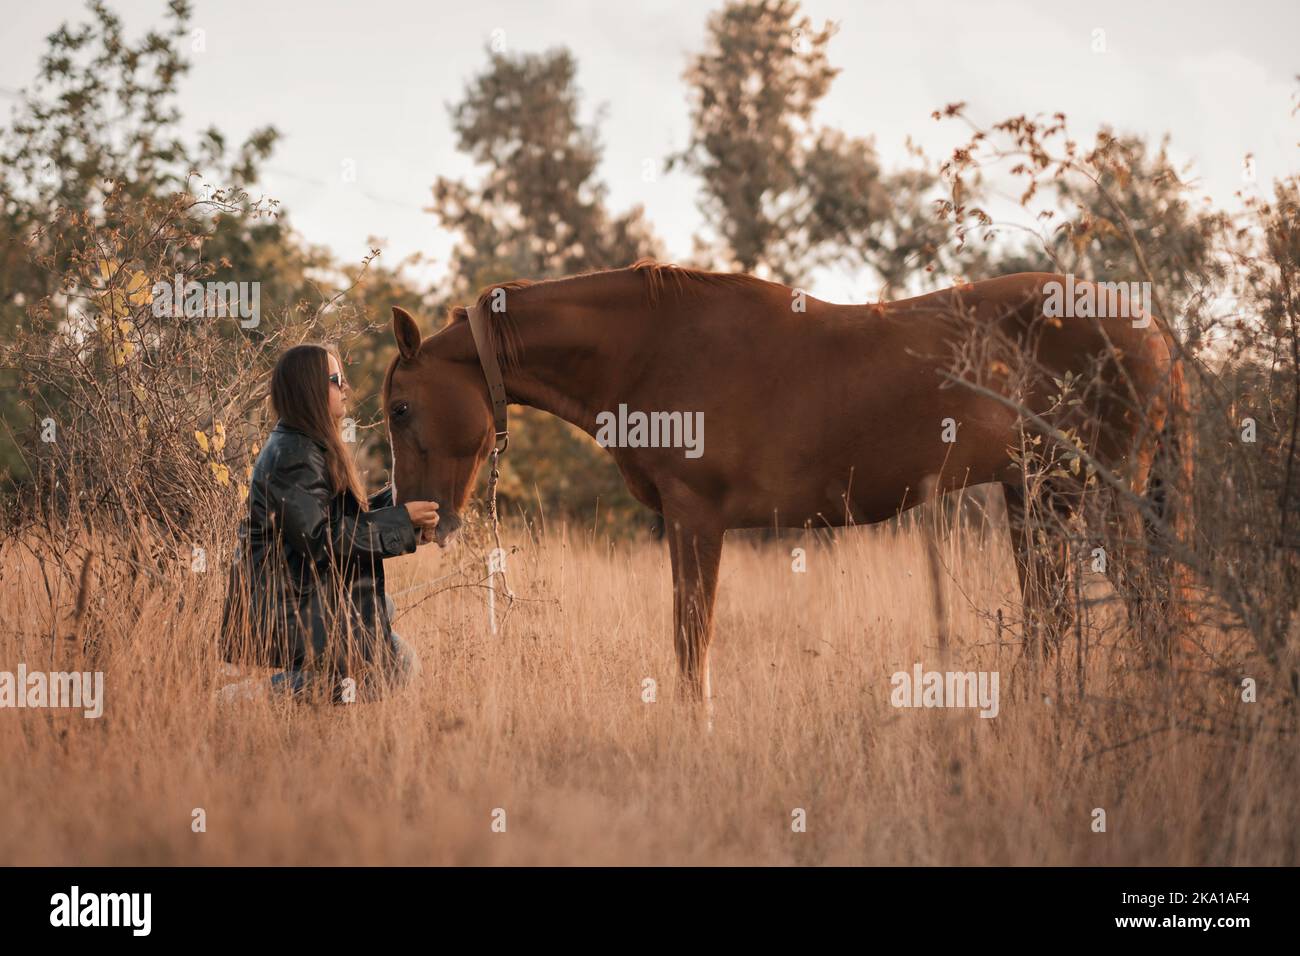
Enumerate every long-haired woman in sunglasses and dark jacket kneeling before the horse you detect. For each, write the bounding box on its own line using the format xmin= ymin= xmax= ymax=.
xmin=221 ymin=345 xmax=438 ymax=701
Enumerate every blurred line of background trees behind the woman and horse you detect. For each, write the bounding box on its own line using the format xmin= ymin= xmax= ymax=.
xmin=0 ymin=0 xmax=1237 ymax=533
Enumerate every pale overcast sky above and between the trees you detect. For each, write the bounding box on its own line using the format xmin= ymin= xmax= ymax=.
xmin=0 ymin=0 xmax=1300 ymax=302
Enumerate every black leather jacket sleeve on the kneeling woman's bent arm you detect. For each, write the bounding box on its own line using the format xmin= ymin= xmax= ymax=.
xmin=267 ymin=441 xmax=416 ymax=564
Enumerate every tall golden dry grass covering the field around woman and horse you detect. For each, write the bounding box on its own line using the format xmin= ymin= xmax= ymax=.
xmin=0 ymin=496 xmax=1300 ymax=865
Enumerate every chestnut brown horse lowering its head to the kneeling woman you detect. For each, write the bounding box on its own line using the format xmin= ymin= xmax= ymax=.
xmin=384 ymin=260 xmax=1186 ymax=700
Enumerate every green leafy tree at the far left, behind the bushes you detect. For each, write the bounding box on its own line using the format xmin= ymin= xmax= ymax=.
xmin=0 ymin=0 xmax=285 ymax=479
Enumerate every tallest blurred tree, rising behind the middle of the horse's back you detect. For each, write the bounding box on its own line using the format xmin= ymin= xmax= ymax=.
xmin=668 ymin=0 xmax=946 ymax=294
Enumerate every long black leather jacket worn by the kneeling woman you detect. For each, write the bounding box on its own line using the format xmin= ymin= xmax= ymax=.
xmin=221 ymin=423 xmax=416 ymax=675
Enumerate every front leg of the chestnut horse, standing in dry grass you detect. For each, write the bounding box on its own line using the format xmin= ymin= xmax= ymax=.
xmin=667 ymin=519 xmax=723 ymax=715
